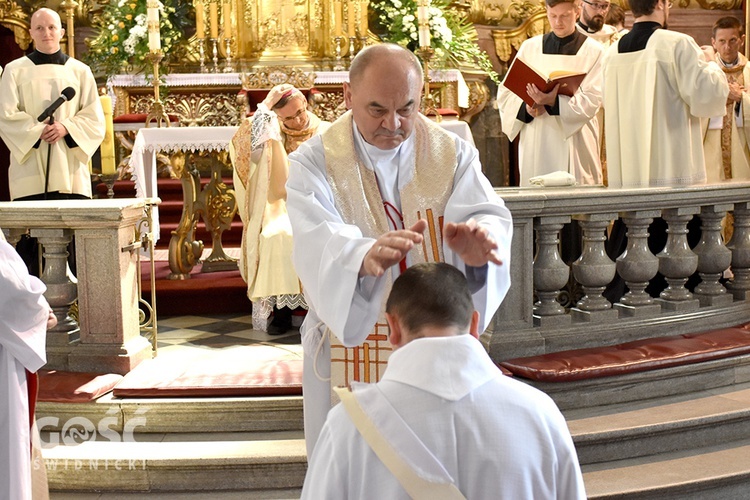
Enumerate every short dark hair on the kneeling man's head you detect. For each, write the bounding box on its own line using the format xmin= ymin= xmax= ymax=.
xmin=385 ymin=262 xmax=474 ymax=338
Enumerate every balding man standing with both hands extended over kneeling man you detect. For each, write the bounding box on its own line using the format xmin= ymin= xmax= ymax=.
xmin=287 ymin=44 xmax=512 ymax=455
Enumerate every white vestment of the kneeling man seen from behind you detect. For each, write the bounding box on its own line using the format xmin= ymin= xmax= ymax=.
xmin=302 ymin=335 xmax=586 ymax=500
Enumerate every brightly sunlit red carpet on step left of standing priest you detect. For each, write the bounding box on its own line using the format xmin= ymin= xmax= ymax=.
xmin=113 ymin=346 xmax=302 ymax=398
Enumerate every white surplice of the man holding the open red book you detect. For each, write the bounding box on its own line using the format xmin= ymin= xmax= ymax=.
xmin=497 ymin=35 xmax=604 ymax=187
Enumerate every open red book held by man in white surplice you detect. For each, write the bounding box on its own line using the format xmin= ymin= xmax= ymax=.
xmin=503 ymin=57 xmax=586 ymax=106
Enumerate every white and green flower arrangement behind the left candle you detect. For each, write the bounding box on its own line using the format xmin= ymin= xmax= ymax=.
xmin=84 ymin=0 xmax=192 ymax=75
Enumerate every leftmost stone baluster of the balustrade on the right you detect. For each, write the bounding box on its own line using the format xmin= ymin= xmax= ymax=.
xmin=534 ymin=215 xmax=570 ymax=326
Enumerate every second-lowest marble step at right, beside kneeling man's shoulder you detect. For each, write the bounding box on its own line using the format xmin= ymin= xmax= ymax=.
xmin=564 ymin=383 xmax=750 ymax=464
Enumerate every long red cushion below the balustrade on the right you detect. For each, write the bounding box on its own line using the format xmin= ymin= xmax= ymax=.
xmin=500 ymin=325 xmax=750 ymax=382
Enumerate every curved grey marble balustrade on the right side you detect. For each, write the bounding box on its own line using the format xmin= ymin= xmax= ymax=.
xmin=490 ymin=182 xmax=750 ymax=361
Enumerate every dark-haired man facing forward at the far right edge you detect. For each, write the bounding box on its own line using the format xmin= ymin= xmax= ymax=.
xmin=703 ymin=16 xmax=750 ymax=182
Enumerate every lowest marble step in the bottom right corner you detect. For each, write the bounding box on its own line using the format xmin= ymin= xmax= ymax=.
xmin=582 ymin=439 xmax=750 ymax=500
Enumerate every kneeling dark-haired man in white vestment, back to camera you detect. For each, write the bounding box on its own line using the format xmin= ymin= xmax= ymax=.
xmin=302 ymin=263 xmax=586 ymax=500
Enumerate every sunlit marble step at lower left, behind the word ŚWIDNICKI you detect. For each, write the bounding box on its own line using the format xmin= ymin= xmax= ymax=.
xmin=42 ymin=431 xmax=307 ymax=492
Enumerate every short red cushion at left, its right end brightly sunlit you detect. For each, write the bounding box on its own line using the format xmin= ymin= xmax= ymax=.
xmin=38 ymin=370 xmax=122 ymax=403
